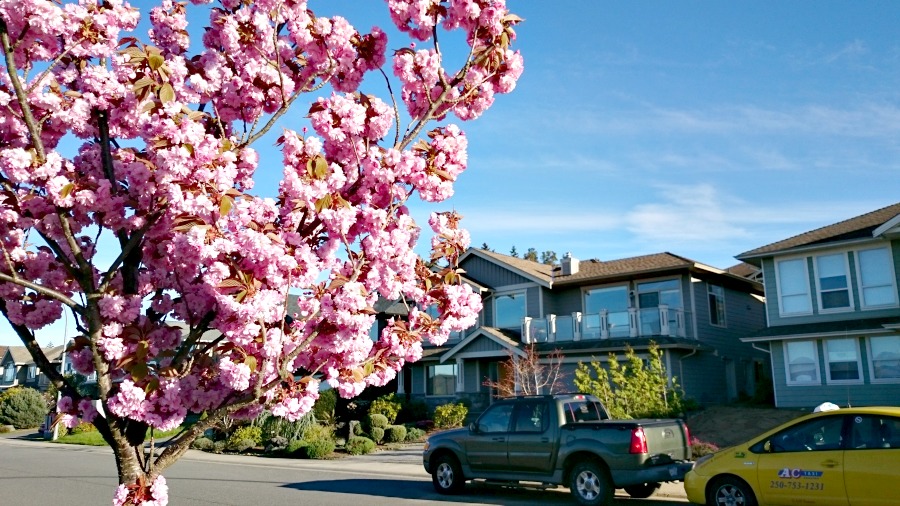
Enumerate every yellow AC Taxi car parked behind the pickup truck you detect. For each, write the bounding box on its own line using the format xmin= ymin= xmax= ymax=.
xmin=684 ymin=407 xmax=900 ymax=506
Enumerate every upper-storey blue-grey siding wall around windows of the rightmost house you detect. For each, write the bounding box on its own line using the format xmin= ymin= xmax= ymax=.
xmin=762 ymin=240 xmax=900 ymax=327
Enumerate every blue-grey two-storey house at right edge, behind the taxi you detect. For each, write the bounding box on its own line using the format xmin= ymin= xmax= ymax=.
xmin=737 ymin=203 xmax=900 ymax=407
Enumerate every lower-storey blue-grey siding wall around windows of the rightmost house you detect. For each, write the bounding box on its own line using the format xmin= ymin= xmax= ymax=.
xmin=771 ymin=339 xmax=900 ymax=409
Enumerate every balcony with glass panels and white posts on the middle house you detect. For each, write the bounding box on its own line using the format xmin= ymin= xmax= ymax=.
xmin=522 ymin=306 xmax=695 ymax=343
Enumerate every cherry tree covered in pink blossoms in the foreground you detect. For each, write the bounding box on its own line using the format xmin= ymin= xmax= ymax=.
xmin=0 ymin=0 xmax=522 ymax=505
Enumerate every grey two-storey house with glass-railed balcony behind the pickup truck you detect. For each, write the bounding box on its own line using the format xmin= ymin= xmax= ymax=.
xmin=398 ymin=249 xmax=768 ymax=412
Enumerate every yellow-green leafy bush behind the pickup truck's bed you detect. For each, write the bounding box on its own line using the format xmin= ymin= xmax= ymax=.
xmin=575 ymin=343 xmax=684 ymax=418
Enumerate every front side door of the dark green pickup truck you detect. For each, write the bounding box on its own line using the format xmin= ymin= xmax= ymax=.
xmin=466 ymin=402 xmax=513 ymax=471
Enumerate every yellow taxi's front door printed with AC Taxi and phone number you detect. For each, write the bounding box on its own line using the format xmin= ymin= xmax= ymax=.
xmin=757 ymin=415 xmax=848 ymax=506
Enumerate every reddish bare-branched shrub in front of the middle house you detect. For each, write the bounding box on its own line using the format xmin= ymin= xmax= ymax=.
xmin=483 ymin=345 xmax=566 ymax=397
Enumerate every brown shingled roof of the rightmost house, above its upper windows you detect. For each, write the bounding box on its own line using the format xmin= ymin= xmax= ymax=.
xmin=735 ymin=202 xmax=900 ymax=261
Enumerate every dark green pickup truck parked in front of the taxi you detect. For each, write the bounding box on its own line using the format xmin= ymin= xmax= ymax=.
xmin=422 ymin=394 xmax=693 ymax=506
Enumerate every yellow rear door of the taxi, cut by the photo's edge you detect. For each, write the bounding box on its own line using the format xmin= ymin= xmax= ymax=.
xmin=844 ymin=415 xmax=900 ymax=506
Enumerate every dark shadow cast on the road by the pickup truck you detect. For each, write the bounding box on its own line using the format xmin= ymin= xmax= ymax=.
xmin=283 ymin=479 xmax=686 ymax=506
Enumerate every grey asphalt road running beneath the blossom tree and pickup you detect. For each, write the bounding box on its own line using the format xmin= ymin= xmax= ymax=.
xmin=0 ymin=438 xmax=685 ymax=506
